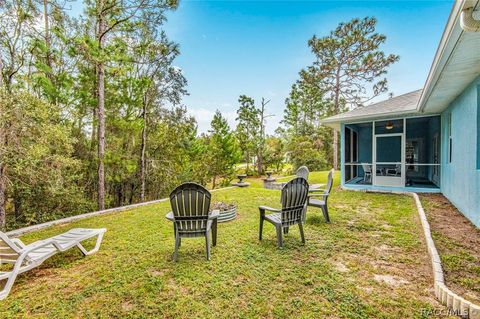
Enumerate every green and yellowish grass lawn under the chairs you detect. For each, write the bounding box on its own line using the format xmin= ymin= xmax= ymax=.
xmin=0 ymin=172 xmax=450 ymax=318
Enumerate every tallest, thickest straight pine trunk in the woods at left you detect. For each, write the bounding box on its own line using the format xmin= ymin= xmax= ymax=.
xmin=97 ymin=0 xmax=106 ymax=210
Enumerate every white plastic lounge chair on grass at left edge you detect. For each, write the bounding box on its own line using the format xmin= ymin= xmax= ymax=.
xmin=0 ymin=228 xmax=107 ymax=300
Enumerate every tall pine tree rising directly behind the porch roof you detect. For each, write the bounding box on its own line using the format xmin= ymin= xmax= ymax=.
xmin=308 ymin=17 xmax=399 ymax=169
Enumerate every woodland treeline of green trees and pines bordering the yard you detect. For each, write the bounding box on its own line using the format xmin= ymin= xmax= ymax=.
xmin=0 ymin=0 xmax=398 ymax=229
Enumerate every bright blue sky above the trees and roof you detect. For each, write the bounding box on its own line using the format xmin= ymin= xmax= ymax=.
xmin=164 ymin=1 xmax=453 ymax=133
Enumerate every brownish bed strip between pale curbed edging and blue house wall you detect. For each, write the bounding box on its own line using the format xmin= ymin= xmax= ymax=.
xmin=420 ymin=194 xmax=480 ymax=304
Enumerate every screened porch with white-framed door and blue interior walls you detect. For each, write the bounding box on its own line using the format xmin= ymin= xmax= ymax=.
xmin=342 ymin=116 xmax=440 ymax=191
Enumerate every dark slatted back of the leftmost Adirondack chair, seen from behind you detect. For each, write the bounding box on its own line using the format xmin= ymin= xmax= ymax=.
xmin=170 ymin=183 xmax=212 ymax=233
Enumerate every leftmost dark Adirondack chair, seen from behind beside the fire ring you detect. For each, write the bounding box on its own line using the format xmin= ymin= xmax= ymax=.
xmin=167 ymin=183 xmax=219 ymax=261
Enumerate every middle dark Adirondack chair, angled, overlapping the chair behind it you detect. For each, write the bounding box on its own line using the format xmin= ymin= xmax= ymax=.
xmin=259 ymin=177 xmax=308 ymax=248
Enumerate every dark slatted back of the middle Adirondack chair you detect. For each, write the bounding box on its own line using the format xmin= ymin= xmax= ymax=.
xmin=281 ymin=177 xmax=308 ymax=226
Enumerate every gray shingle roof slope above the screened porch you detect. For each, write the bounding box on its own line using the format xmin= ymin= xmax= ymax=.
xmin=321 ymin=89 xmax=422 ymax=124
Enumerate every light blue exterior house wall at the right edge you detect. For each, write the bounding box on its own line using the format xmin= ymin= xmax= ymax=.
xmin=440 ymin=77 xmax=480 ymax=227
